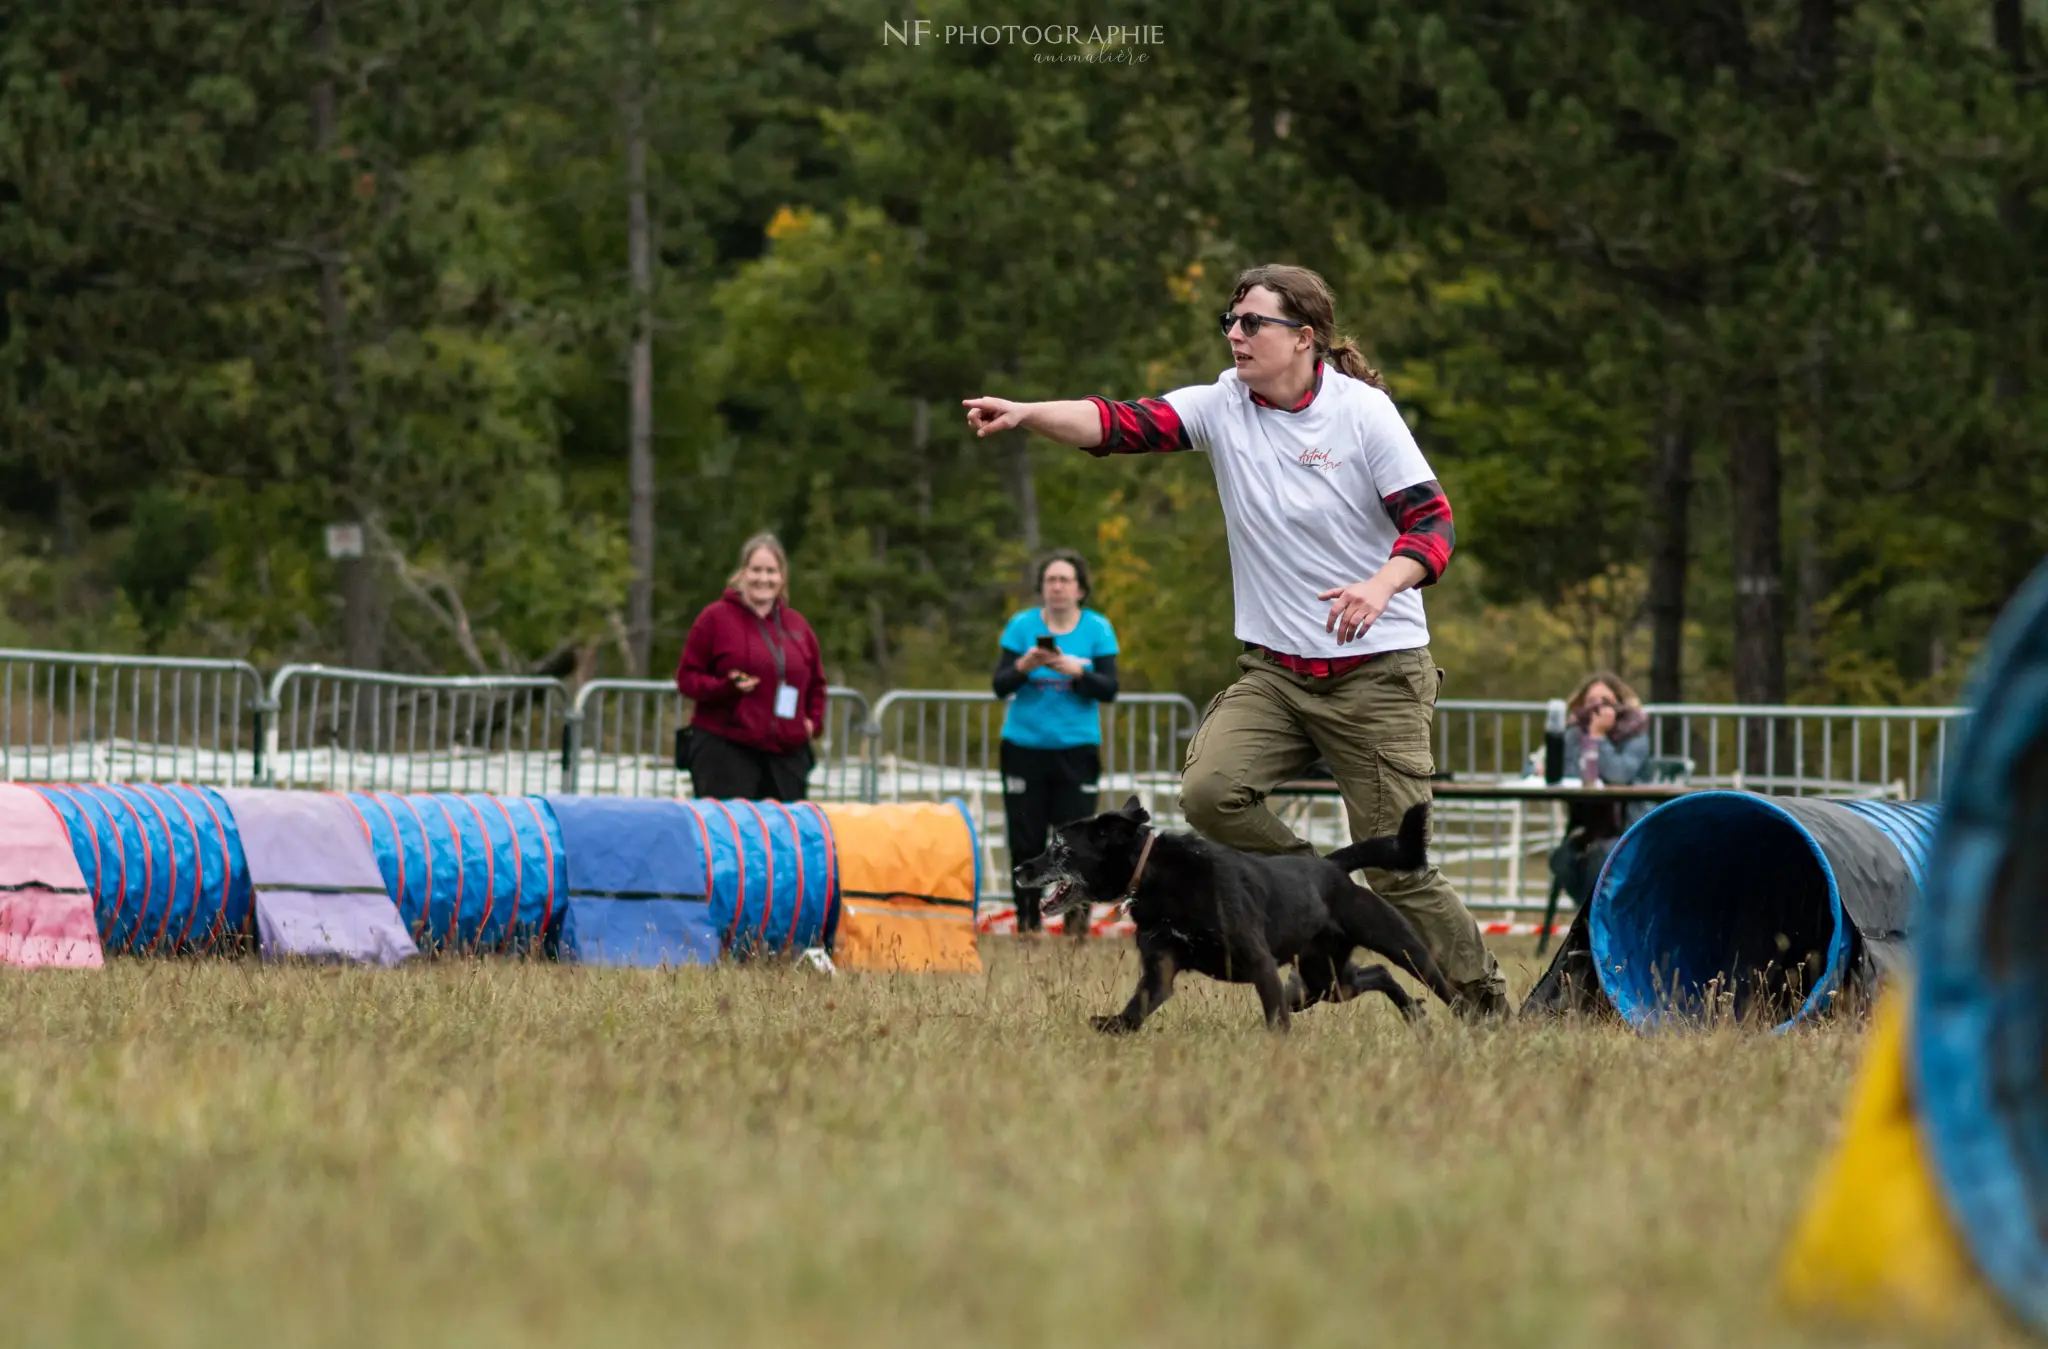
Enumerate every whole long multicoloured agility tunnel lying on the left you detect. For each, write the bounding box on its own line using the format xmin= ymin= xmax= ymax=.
xmin=0 ymin=784 xmax=981 ymax=970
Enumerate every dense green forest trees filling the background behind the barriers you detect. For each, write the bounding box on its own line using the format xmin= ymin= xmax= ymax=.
xmin=0 ymin=0 xmax=2048 ymax=700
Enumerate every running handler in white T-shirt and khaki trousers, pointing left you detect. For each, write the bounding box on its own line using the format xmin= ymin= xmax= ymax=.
xmin=965 ymin=266 xmax=1509 ymax=1017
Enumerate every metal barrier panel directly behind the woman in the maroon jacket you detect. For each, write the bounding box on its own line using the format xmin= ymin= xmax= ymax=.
xmin=561 ymin=680 xmax=868 ymax=800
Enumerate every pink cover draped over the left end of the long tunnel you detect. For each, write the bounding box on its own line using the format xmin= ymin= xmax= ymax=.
xmin=0 ymin=782 xmax=106 ymax=970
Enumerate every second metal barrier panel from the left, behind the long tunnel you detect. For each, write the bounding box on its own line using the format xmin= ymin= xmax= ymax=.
xmin=266 ymin=665 xmax=569 ymax=796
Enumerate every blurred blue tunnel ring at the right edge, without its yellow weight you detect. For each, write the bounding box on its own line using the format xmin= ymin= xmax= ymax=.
xmin=1907 ymin=563 xmax=2048 ymax=1333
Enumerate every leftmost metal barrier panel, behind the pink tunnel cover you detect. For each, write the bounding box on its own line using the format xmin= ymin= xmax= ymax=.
xmin=0 ymin=651 xmax=264 ymax=786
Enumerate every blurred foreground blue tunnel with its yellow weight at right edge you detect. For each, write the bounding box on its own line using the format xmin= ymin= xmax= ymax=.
xmin=1780 ymin=552 xmax=2048 ymax=1335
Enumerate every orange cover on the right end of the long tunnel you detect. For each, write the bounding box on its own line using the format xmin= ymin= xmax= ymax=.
xmin=819 ymin=798 xmax=981 ymax=972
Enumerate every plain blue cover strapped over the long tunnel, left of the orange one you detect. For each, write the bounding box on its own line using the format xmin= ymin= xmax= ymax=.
xmin=547 ymin=796 xmax=723 ymax=966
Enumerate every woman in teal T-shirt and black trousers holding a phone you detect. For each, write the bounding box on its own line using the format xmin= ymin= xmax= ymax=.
xmin=993 ymin=549 xmax=1116 ymax=938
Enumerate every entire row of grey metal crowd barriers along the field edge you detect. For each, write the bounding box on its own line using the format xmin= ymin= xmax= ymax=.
xmin=0 ymin=649 xmax=1968 ymax=909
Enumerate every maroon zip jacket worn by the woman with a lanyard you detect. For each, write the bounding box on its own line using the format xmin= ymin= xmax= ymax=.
xmin=676 ymin=590 xmax=825 ymax=753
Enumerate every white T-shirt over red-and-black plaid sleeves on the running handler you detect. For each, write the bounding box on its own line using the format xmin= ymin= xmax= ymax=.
xmin=1090 ymin=362 xmax=1456 ymax=661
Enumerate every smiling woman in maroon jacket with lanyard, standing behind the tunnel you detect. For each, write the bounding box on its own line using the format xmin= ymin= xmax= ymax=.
xmin=676 ymin=534 xmax=825 ymax=800
